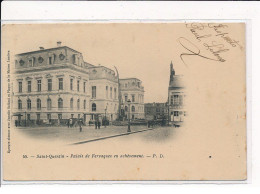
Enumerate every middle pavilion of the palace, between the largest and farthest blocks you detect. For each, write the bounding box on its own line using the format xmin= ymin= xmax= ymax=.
xmin=89 ymin=66 xmax=118 ymax=121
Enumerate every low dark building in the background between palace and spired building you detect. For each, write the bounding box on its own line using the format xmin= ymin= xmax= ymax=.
xmin=144 ymin=102 xmax=168 ymax=120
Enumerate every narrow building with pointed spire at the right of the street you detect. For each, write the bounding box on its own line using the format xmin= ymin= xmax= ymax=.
xmin=168 ymin=62 xmax=186 ymax=123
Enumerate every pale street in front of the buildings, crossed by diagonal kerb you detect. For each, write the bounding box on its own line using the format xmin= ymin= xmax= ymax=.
xmin=14 ymin=126 xmax=175 ymax=144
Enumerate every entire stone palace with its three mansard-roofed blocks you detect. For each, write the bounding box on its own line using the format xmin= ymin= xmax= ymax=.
xmin=12 ymin=42 xmax=144 ymax=126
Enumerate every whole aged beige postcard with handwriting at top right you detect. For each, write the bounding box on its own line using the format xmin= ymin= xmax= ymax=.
xmin=1 ymin=21 xmax=247 ymax=181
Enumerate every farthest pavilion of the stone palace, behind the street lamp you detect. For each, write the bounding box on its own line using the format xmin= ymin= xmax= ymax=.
xmin=120 ymin=78 xmax=144 ymax=119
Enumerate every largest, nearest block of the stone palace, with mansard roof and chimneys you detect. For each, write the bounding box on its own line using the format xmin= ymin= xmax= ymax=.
xmin=13 ymin=42 xmax=90 ymax=125
